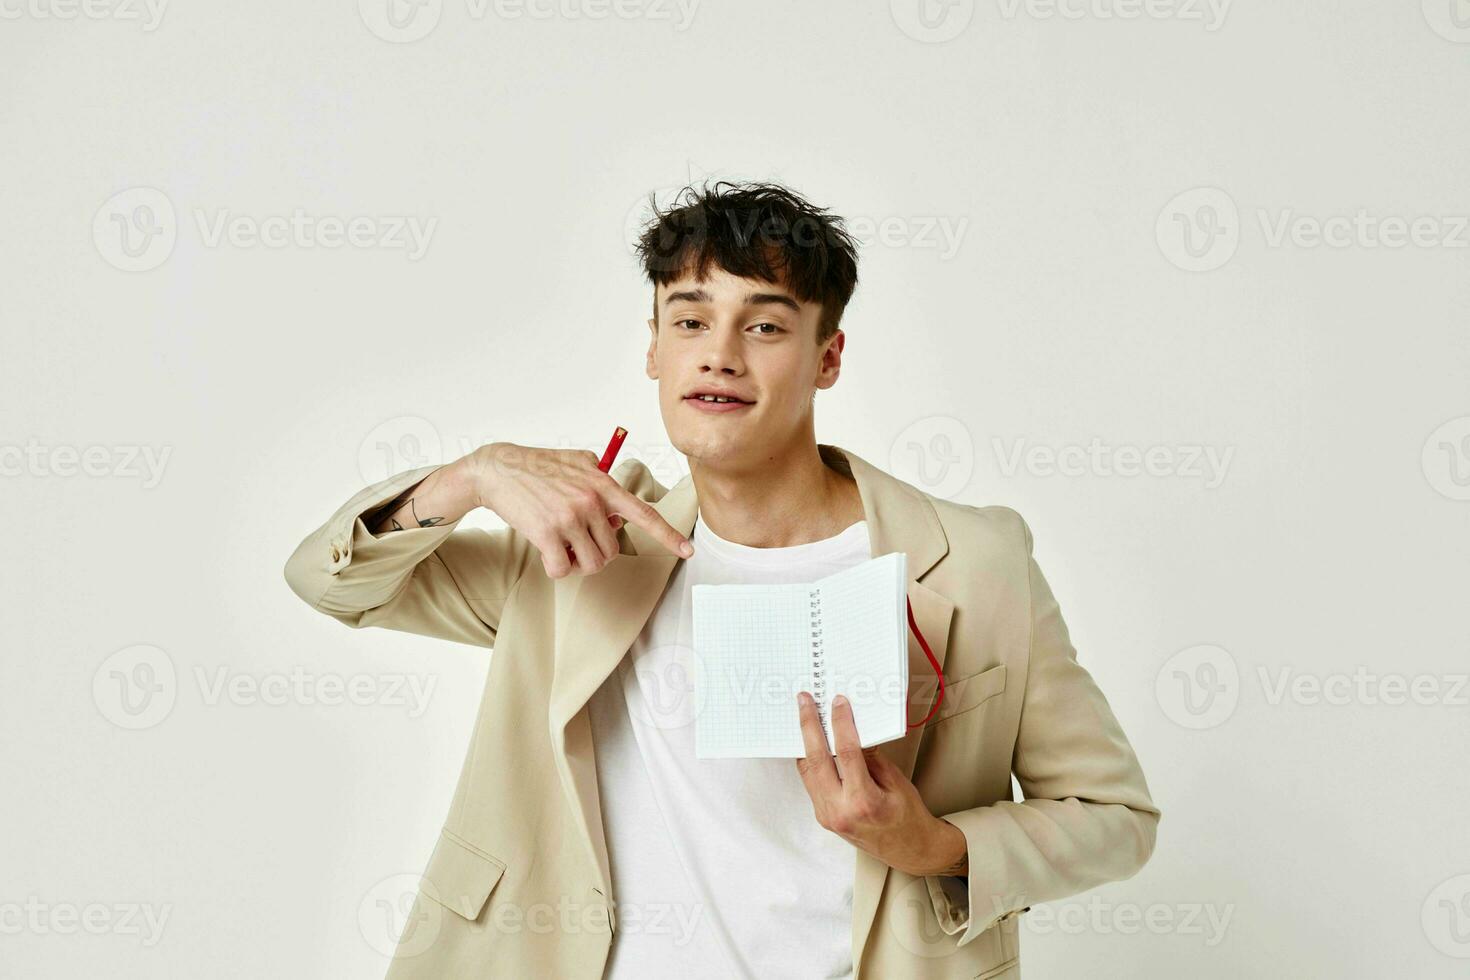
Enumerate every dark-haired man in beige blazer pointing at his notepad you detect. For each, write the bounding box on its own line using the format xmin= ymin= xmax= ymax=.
xmin=285 ymin=182 xmax=1160 ymax=980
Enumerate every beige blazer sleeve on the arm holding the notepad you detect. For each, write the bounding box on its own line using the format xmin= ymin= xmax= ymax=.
xmin=925 ymin=514 xmax=1160 ymax=946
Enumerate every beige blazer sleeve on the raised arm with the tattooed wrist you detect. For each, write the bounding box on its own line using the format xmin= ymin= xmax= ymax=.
xmin=285 ymin=466 xmax=539 ymax=646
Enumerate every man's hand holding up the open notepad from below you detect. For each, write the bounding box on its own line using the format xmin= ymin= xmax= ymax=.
xmin=797 ymin=691 xmax=970 ymax=876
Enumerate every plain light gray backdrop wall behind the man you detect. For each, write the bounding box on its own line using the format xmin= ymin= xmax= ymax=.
xmin=0 ymin=0 xmax=1470 ymax=979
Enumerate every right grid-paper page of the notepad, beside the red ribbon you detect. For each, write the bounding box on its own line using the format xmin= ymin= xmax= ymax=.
xmin=816 ymin=551 xmax=908 ymax=752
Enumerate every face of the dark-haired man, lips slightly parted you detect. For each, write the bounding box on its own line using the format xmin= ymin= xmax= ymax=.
xmin=647 ymin=266 xmax=844 ymax=463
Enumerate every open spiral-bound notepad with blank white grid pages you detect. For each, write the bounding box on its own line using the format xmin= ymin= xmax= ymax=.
xmin=692 ymin=551 xmax=908 ymax=758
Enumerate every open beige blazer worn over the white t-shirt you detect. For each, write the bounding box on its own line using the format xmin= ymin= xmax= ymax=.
xmin=285 ymin=445 xmax=1160 ymax=980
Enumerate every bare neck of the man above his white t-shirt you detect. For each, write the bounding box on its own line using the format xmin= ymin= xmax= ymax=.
xmin=689 ymin=442 xmax=864 ymax=548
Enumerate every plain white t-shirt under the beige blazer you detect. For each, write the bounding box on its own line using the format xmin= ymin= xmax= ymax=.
xmin=588 ymin=520 xmax=872 ymax=980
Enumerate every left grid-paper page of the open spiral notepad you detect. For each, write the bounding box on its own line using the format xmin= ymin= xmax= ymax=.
xmin=692 ymin=583 xmax=811 ymax=758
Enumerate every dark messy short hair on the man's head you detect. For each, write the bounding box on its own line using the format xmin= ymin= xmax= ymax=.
xmin=637 ymin=181 xmax=857 ymax=344
